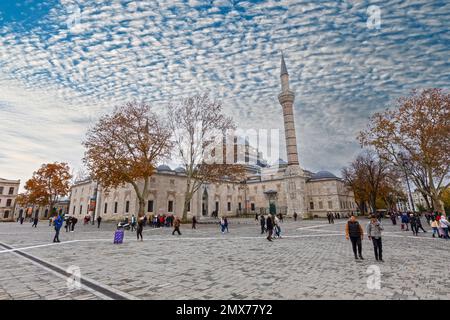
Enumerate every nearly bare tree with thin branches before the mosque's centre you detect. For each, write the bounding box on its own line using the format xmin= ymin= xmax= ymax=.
xmin=168 ymin=93 xmax=244 ymax=220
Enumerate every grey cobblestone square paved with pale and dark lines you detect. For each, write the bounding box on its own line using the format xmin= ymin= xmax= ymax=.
xmin=0 ymin=218 xmax=450 ymax=300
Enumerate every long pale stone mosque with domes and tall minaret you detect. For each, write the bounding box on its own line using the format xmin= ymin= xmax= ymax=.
xmin=69 ymin=56 xmax=357 ymax=220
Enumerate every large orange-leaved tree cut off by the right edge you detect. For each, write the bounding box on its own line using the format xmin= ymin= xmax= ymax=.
xmin=359 ymin=89 xmax=450 ymax=211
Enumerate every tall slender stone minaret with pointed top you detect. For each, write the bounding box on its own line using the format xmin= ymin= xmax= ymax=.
xmin=278 ymin=53 xmax=299 ymax=167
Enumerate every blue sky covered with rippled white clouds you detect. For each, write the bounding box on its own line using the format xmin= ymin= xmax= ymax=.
xmin=0 ymin=0 xmax=450 ymax=188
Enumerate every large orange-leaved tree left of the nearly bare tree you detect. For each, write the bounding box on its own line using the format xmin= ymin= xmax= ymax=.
xmin=83 ymin=102 xmax=172 ymax=216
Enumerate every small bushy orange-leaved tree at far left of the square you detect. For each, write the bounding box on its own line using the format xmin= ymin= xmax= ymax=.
xmin=24 ymin=162 xmax=72 ymax=213
